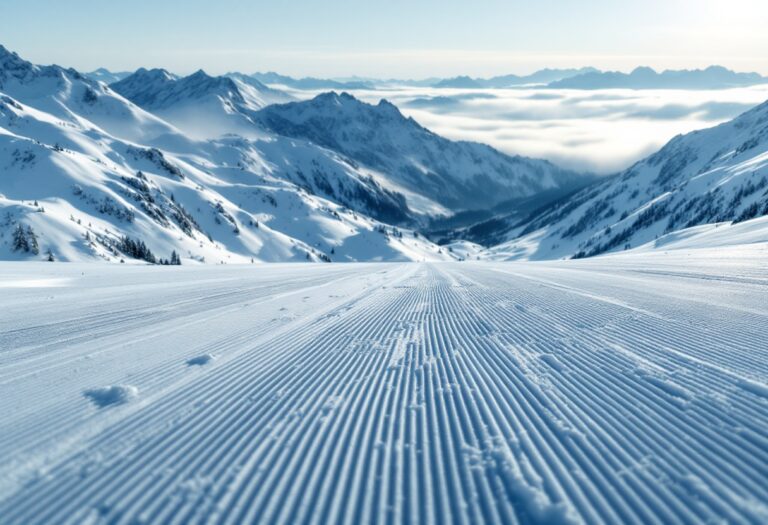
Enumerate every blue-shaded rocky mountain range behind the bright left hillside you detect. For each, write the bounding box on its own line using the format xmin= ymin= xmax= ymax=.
xmin=111 ymin=70 xmax=590 ymax=219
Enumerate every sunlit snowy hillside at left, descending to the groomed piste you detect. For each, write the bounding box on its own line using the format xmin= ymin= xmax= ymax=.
xmin=0 ymin=90 xmax=456 ymax=263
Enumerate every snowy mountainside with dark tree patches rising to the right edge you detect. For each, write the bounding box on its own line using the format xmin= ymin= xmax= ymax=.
xmin=489 ymin=97 xmax=768 ymax=259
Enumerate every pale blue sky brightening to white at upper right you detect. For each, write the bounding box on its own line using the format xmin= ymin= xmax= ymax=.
xmin=0 ymin=0 xmax=768 ymax=77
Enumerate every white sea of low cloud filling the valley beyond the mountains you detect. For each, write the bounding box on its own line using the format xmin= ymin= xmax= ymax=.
xmin=340 ymin=85 xmax=768 ymax=174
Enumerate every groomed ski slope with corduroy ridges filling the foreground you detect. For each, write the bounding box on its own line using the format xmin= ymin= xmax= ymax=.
xmin=0 ymin=244 xmax=768 ymax=524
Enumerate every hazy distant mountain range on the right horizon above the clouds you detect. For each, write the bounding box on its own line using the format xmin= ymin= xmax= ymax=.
xmin=549 ymin=66 xmax=768 ymax=89
